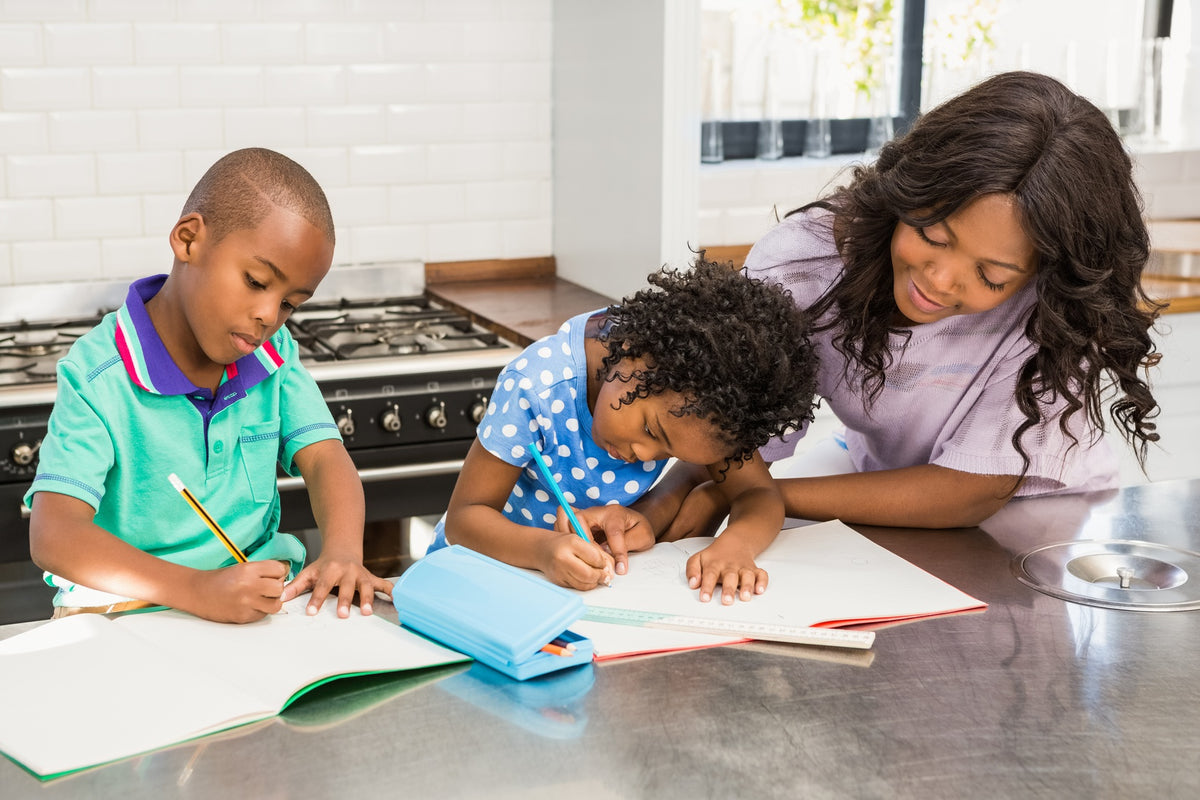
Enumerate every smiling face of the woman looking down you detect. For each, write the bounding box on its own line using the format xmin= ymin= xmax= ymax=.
xmin=892 ymin=194 xmax=1037 ymax=325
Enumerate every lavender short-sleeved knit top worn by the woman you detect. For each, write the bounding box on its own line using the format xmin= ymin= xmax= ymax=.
xmin=745 ymin=211 xmax=1117 ymax=497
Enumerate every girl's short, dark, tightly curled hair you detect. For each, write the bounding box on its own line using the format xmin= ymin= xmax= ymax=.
xmin=598 ymin=256 xmax=816 ymax=464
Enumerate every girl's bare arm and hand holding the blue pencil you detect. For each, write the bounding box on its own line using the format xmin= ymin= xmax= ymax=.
xmin=445 ymin=439 xmax=613 ymax=589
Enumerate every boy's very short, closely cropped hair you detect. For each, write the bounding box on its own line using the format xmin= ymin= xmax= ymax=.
xmin=180 ymin=148 xmax=334 ymax=242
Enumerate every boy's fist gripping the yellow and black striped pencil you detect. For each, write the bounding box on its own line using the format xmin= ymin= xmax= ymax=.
xmin=184 ymin=560 xmax=288 ymax=622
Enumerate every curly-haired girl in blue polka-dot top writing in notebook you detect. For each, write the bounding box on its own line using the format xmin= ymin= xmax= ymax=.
xmin=431 ymin=260 xmax=815 ymax=603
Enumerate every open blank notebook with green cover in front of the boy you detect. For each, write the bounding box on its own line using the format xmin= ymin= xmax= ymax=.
xmin=0 ymin=595 xmax=469 ymax=780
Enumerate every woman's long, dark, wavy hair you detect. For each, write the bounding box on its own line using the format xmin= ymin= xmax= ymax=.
xmin=793 ymin=72 xmax=1160 ymax=475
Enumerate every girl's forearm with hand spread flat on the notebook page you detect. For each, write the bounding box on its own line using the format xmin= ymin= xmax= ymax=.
xmin=686 ymin=453 xmax=784 ymax=604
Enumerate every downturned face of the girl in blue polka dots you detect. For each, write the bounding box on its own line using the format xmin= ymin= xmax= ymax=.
xmin=592 ymin=362 xmax=731 ymax=464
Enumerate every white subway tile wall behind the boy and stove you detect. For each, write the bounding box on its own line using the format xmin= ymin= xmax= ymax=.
xmin=0 ymin=0 xmax=552 ymax=287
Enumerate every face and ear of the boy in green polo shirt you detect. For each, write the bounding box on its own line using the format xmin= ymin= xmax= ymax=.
xmin=172 ymin=206 xmax=334 ymax=365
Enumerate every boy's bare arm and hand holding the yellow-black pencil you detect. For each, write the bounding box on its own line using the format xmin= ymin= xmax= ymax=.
xmin=29 ymin=492 xmax=288 ymax=622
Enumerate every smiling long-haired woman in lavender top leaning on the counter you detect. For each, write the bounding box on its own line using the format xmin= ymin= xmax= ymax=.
xmin=648 ymin=72 xmax=1158 ymax=539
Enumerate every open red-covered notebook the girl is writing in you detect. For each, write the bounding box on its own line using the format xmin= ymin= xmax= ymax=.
xmin=571 ymin=519 xmax=986 ymax=661
